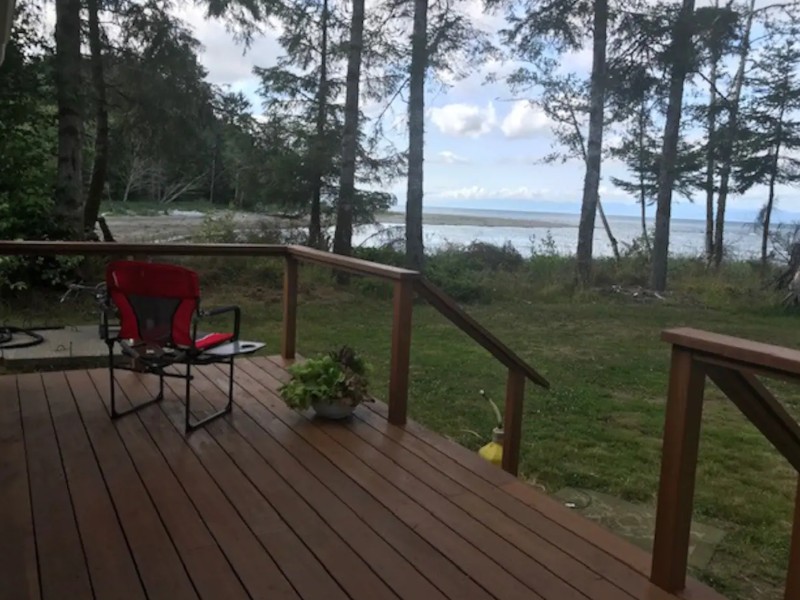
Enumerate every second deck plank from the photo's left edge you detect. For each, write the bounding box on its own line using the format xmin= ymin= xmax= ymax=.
xmin=18 ymin=373 xmax=92 ymax=600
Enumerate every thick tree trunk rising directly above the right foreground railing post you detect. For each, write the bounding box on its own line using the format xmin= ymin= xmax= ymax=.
xmin=650 ymin=0 xmax=694 ymax=292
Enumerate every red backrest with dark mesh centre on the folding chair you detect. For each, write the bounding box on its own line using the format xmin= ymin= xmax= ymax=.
xmin=106 ymin=260 xmax=200 ymax=346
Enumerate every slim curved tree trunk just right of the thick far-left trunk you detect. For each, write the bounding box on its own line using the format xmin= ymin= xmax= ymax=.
xmin=83 ymin=0 xmax=109 ymax=237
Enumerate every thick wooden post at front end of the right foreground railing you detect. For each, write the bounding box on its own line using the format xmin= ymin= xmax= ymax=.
xmin=650 ymin=346 xmax=705 ymax=593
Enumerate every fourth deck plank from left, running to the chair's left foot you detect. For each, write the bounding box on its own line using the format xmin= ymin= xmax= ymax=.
xmin=65 ymin=371 xmax=197 ymax=600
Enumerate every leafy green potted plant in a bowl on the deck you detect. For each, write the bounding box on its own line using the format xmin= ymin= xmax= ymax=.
xmin=280 ymin=346 xmax=373 ymax=419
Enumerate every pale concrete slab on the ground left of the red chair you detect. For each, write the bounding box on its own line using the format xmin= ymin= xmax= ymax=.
xmin=0 ymin=325 xmax=115 ymax=370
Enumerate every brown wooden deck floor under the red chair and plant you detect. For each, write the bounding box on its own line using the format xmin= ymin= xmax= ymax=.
xmin=0 ymin=358 xmax=719 ymax=600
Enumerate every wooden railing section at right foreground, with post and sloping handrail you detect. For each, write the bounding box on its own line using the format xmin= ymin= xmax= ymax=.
xmin=651 ymin=328 xmax=800 ymax=600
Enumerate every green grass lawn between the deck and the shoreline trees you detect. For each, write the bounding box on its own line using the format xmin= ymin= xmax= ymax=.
xmin=0 ymin=253 xmax=800 ymax=600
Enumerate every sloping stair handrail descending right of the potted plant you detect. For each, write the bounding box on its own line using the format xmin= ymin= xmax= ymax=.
xmin=416 ymin=277 xmax=550 ymax=389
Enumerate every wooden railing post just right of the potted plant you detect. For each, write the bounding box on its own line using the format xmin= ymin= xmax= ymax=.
xmin=389 ymin=278 xmax=414 ymax=425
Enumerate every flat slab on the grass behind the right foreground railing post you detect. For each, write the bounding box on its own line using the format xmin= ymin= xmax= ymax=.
xmin=555 ymin=488 xmax=725 ymax=569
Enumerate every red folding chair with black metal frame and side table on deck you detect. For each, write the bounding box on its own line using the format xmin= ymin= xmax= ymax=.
xmin=104 ymin=260 xmax=264 ymax=432
